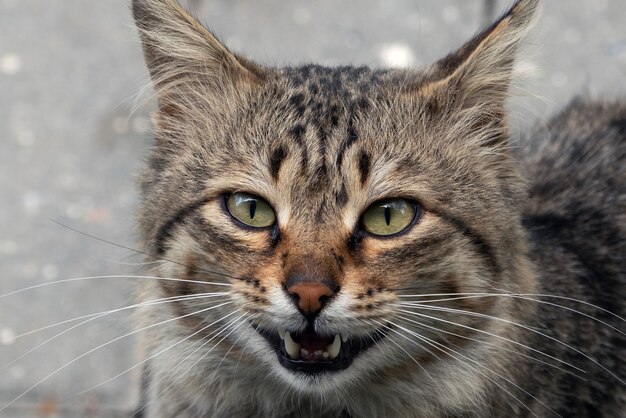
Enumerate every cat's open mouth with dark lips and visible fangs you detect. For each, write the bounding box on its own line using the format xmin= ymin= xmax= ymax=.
xmin=259 ymin=326 xmax=386 ymax=374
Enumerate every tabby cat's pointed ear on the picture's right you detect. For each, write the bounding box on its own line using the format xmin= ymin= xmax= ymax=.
xmin=412 ymin=0 xmax=538 ymax=118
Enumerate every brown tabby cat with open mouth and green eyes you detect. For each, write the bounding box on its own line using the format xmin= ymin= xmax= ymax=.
xmin=132 ymin=0 xmax=626 ymax=418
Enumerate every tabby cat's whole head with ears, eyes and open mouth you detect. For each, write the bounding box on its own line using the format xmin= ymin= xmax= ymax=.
xmin=133 ymin=0 xmax=537 ymax=404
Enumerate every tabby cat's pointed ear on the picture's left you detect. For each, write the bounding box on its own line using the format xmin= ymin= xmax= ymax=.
xmin=132 ymin=0 xmax=263 ymax=99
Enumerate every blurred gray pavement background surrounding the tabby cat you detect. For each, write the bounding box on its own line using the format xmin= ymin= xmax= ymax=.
xmin=0 ymin=0 xmax=626 ymax=417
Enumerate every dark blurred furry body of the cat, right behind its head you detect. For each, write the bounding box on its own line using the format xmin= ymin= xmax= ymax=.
xmin=520 ymin=100 xmax=626 ymax=417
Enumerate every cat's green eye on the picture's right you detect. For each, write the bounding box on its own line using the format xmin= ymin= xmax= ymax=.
xmin=361 ymin=199 xmax=416 ymax=235
